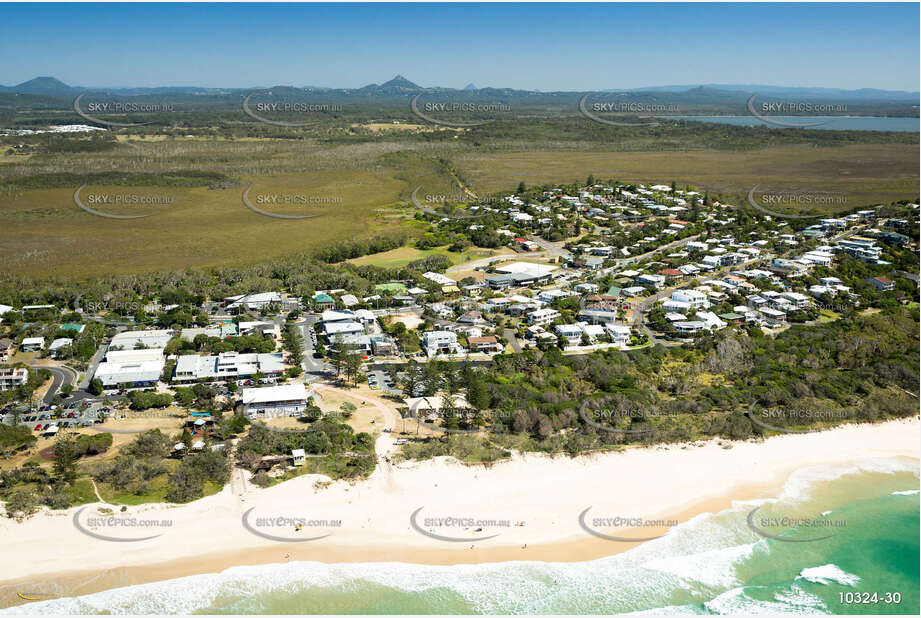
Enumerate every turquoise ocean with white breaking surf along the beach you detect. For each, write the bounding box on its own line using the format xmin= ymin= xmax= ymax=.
xmin=0 ymin=459 xmax=921 ymax=615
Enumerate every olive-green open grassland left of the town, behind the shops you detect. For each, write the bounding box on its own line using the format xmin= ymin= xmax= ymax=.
xmin=0 ymin=170 xmax=403 ymax=276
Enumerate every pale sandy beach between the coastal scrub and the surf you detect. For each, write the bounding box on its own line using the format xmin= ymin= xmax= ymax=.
xmin=0 ymin=419 xmax=921 ymax=606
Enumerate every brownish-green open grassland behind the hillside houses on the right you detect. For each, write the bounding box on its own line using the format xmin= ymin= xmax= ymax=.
xmin=455 ymin=144 xmax=919 ymax=214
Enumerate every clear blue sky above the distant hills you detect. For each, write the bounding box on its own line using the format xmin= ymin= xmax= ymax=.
xmin=0 ymin=3 xmax=919 ymax=91
